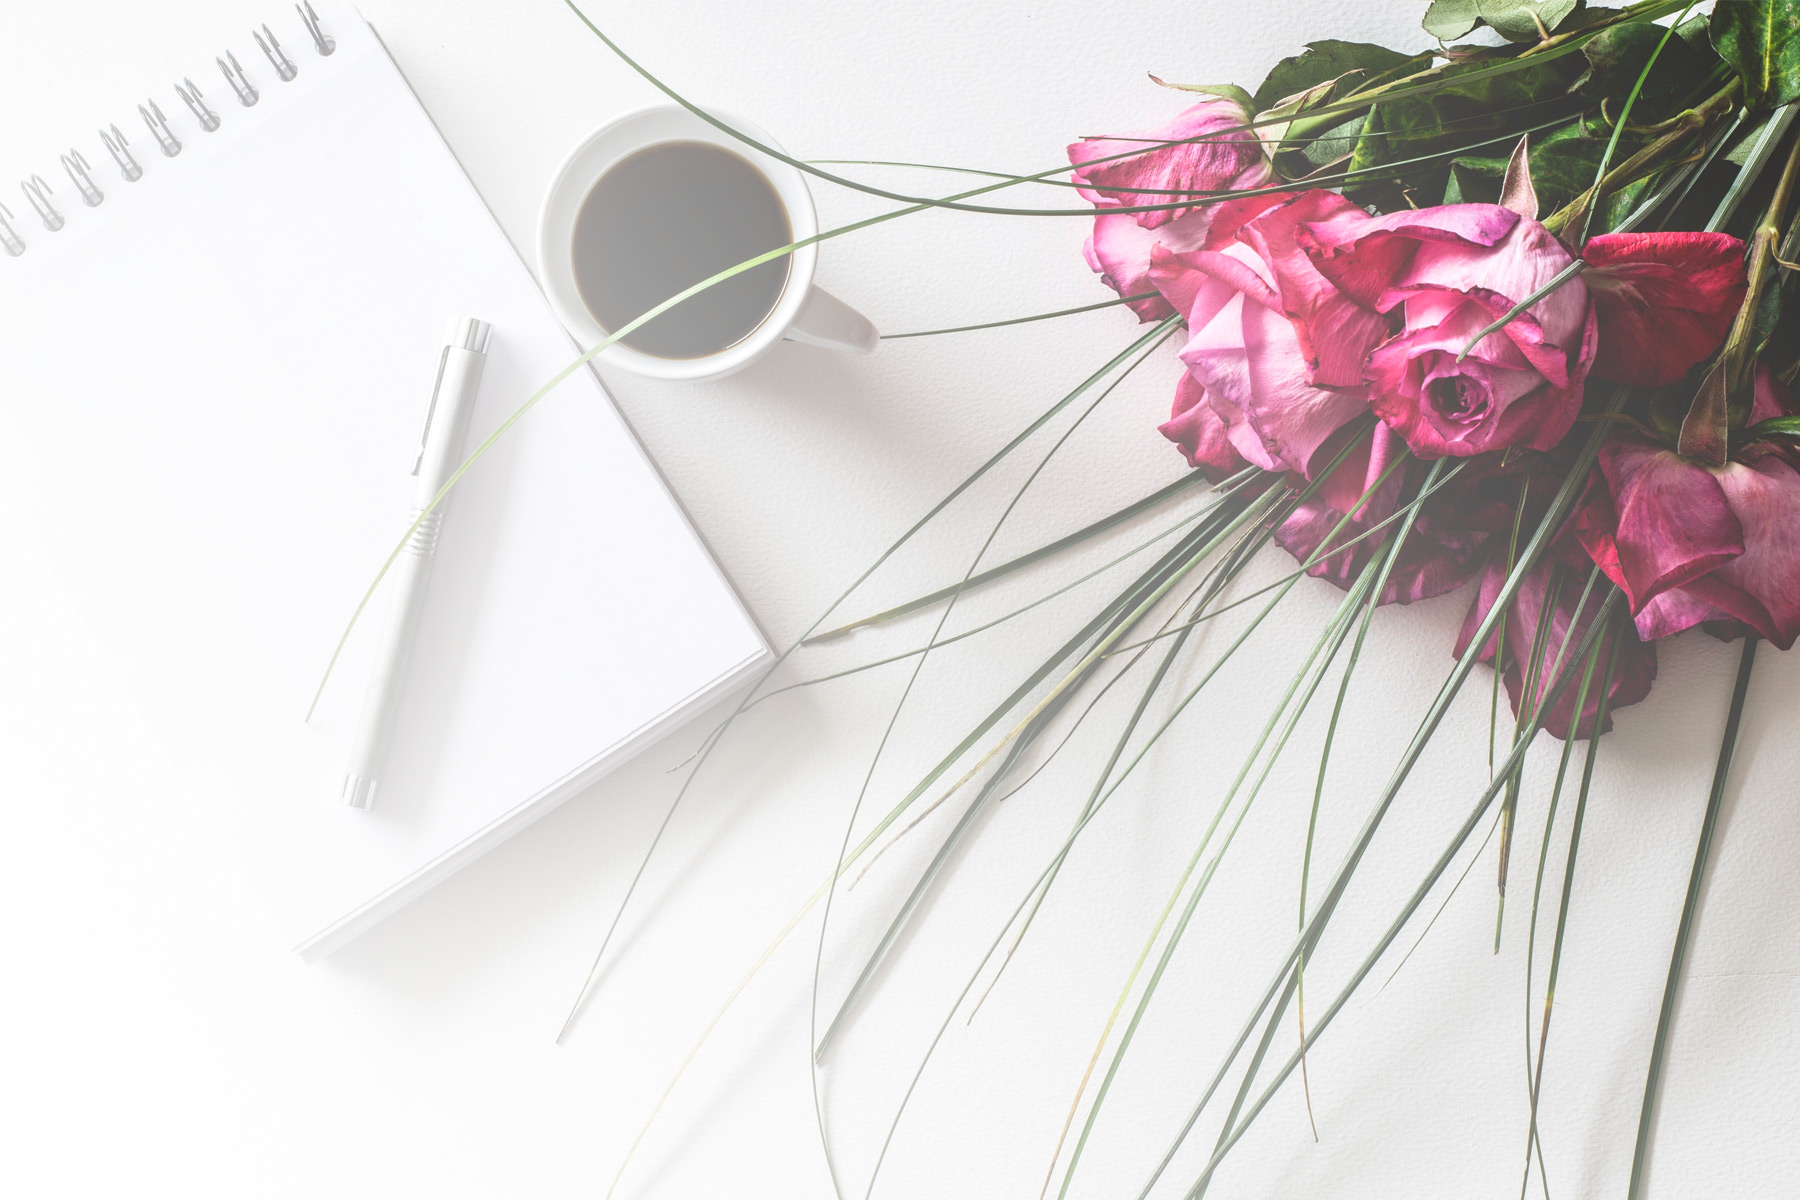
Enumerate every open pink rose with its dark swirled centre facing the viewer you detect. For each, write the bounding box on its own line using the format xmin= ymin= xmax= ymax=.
xmin=1298 ymin=203 xmax=1598 ymax=459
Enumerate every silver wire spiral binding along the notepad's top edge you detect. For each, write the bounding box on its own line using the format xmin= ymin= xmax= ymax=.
xmin=0 ymin=0 xmax=337 ymax=259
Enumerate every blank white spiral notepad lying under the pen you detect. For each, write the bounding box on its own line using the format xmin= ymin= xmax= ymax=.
xmin=0 ymin=5 xmax=769 ymax=955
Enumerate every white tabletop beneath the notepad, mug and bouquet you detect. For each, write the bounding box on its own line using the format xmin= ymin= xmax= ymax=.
xmin=0 ymin=0 xmax=1800 ymax=1200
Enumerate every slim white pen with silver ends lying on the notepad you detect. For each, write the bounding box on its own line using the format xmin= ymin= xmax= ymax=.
xmin=344 ymin=317 xmax=493 ymax=808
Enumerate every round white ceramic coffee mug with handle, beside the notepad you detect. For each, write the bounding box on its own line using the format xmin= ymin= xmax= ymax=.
xmin=538 ymin=104 xmax=880 ymax=380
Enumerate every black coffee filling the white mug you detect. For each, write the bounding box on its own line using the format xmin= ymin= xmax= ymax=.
xmin=574 ymin=142 xmax=794 ymax=358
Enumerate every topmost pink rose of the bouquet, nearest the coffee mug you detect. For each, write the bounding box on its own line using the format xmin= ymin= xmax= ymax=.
xmin=1069 ymin=97 xmax=1274 ymax=320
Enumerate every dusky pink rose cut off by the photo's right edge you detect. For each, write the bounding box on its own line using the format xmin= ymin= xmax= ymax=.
xmin=1577 ymin=367 xmax=1800 ymax=649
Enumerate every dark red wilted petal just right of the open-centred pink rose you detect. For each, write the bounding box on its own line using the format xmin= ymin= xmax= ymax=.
xmin=1582 ymin=232 xmax=1748 ymax=387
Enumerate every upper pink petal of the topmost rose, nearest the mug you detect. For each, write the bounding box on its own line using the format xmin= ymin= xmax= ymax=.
xmin=1069 ymin=97 xmax=1274 ymax=228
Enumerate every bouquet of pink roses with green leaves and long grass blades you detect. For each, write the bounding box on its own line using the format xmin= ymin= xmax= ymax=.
xmin=327 ymin=0 xmax=1800 ymax=1196
